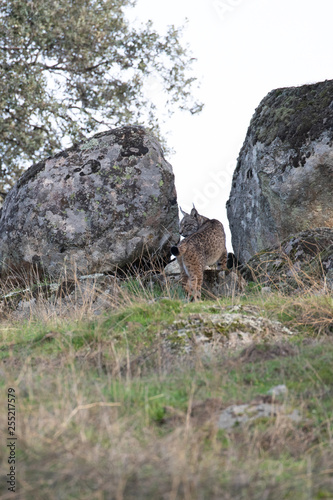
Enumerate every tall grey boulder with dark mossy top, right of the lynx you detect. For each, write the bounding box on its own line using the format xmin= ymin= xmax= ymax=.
xmin=227 ymin=80 xmax=333 ymax=262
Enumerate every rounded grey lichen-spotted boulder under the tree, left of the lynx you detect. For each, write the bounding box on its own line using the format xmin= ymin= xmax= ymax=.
xmin=0 ymin=127 xmax=179 ymax=277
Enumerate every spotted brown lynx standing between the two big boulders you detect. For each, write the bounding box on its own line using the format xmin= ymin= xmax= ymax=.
xmin=171 ymin=208 xmax=227 ymax=300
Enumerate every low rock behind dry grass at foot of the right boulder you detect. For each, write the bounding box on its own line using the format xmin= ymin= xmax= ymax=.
xmin=242 ymin=227 xmax=333 ymax=292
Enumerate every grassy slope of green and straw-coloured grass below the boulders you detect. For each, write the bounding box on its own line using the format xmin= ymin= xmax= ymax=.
xmin=0 ymin=282 xmax=333 ymax=500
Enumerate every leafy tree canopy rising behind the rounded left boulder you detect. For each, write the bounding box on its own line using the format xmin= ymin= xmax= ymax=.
xmin=0 ymin=0 xmax=202 ymax=191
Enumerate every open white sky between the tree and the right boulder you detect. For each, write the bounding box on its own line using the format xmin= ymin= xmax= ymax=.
xmin=129 ymin=0 xmax=333 ymax=251
